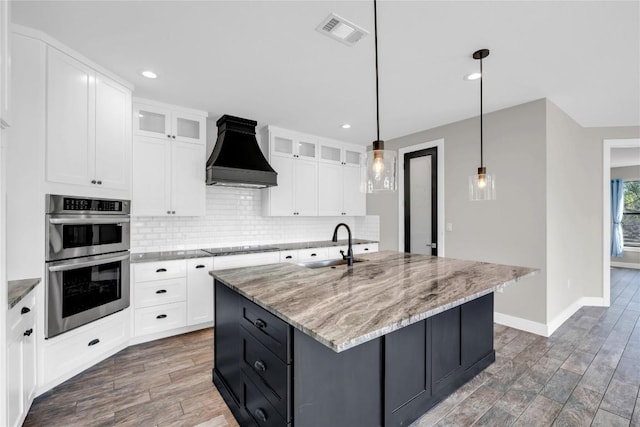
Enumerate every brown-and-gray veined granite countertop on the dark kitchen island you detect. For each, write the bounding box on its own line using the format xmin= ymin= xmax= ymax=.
xmin=210 ymin=251 xmax=538 ymax=352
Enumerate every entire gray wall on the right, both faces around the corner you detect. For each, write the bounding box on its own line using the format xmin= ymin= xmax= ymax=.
xmin=367 ymin=99 xmax=640 ymax=324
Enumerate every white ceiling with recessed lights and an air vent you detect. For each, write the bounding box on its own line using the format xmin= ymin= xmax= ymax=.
xmin=11 ymin=0 xmax=640 ymax=144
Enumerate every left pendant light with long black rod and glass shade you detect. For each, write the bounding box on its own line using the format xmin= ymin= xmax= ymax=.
xmin=360 ymin=0 xmax=398 ymax=193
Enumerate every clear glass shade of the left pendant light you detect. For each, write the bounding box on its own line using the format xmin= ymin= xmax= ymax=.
xmin=360 ymin=141 xmax=398 ymax=193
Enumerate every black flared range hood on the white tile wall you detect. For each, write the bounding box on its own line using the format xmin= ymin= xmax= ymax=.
xmin=207 ymin=114 xmax=278 ymax=188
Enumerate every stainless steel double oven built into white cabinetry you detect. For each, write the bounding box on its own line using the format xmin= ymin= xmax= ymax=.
xmin=45 ymin=194 xmax=130 ymax=338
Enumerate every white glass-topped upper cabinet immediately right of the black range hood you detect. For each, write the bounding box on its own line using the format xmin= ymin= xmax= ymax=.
xmin=262 ymin=127 xmax=318 ymax=216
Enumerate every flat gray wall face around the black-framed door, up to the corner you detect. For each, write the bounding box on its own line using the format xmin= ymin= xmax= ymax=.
xmin=367 ymin=100 xmax=546 ymax=323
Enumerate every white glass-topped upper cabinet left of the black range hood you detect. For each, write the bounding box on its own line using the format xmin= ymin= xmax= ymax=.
xmin=132 ymin=100 xmax=207 ymax=216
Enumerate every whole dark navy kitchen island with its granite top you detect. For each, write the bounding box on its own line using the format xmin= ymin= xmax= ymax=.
xmin=212 ymin=251 xmax=536 ymax=427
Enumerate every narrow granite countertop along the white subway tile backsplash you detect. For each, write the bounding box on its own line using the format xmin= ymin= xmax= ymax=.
xmin=131 ymin=239 xmax=378 ymax=263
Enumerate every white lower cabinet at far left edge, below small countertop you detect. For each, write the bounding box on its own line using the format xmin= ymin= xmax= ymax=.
xmin=6 ymin=291 xmax=36 ymax=427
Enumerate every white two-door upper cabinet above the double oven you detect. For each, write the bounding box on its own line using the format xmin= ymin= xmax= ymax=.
xmin=46 ymin=46 xmax=131 ymax=192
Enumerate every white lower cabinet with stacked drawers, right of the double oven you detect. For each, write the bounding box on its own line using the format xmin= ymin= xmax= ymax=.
xmin=132 ymin=257 xmax=213 ymax=337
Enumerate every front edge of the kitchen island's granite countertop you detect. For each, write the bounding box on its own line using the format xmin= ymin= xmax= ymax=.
xmin=209 ymin=271 xmax=538 ymax=353
